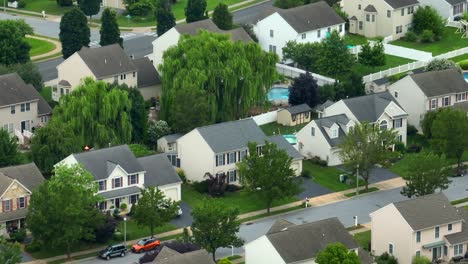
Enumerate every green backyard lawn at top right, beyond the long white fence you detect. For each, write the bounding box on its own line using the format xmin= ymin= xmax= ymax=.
xmin=390 ymin=27 xmax=468 ymax=56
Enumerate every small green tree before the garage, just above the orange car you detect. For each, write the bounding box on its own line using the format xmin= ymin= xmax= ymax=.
xmin=133 ymin=186 xmax=178 ymax=236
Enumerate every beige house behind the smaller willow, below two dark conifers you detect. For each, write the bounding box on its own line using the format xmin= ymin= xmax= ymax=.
xmin=52 ymin=44 xmax=161 ymax=101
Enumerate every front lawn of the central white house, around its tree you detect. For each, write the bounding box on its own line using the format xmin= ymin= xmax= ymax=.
xmin=182 ymin=184 xmax=297 ymax=214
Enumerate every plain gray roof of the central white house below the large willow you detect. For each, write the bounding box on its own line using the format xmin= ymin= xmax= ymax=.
xmin=196 ymin=118 xmax=268 ymax=153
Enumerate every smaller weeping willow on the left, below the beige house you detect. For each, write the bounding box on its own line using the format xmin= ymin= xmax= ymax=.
xmin=52 ymin=79 xmax=132 ymax=147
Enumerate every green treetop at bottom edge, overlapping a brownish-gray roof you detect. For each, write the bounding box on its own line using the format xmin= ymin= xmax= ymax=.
xmin=315 ymin=243 xmax=361 ymax=264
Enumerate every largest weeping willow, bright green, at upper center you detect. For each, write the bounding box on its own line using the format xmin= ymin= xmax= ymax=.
xmin=159 ymin=31 xmax=278 ymax=127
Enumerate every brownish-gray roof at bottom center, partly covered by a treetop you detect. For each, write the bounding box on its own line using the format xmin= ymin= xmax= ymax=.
xmin=266 ymin=217 xmax=358 ymax=263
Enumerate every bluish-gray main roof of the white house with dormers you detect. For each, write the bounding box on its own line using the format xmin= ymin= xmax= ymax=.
xmin=343 ymin=91 xmax=401 ymax=123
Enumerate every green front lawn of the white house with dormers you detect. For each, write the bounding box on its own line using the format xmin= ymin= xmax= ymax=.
xmin=302 ymin=160 xmax=364 ymax=192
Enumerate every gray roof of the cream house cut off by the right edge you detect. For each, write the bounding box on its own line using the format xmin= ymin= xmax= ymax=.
xmin=410 ymin=69 xmax=468 ymax=97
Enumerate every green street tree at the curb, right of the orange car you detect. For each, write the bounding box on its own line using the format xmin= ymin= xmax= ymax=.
xmin=192 ymin=199 xmax=244 ymax=261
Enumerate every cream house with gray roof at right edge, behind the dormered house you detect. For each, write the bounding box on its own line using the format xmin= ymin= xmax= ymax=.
xmin=388 ymin=69 xmax=468 ymax=132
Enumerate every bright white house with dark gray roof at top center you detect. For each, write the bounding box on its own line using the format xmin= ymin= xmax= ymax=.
xmin=253 ymin=1 xmax=345 ymax=59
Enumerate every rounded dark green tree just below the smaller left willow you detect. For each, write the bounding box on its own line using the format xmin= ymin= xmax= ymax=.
xmin=31 ymin=122 xmax=84 ymax=175
